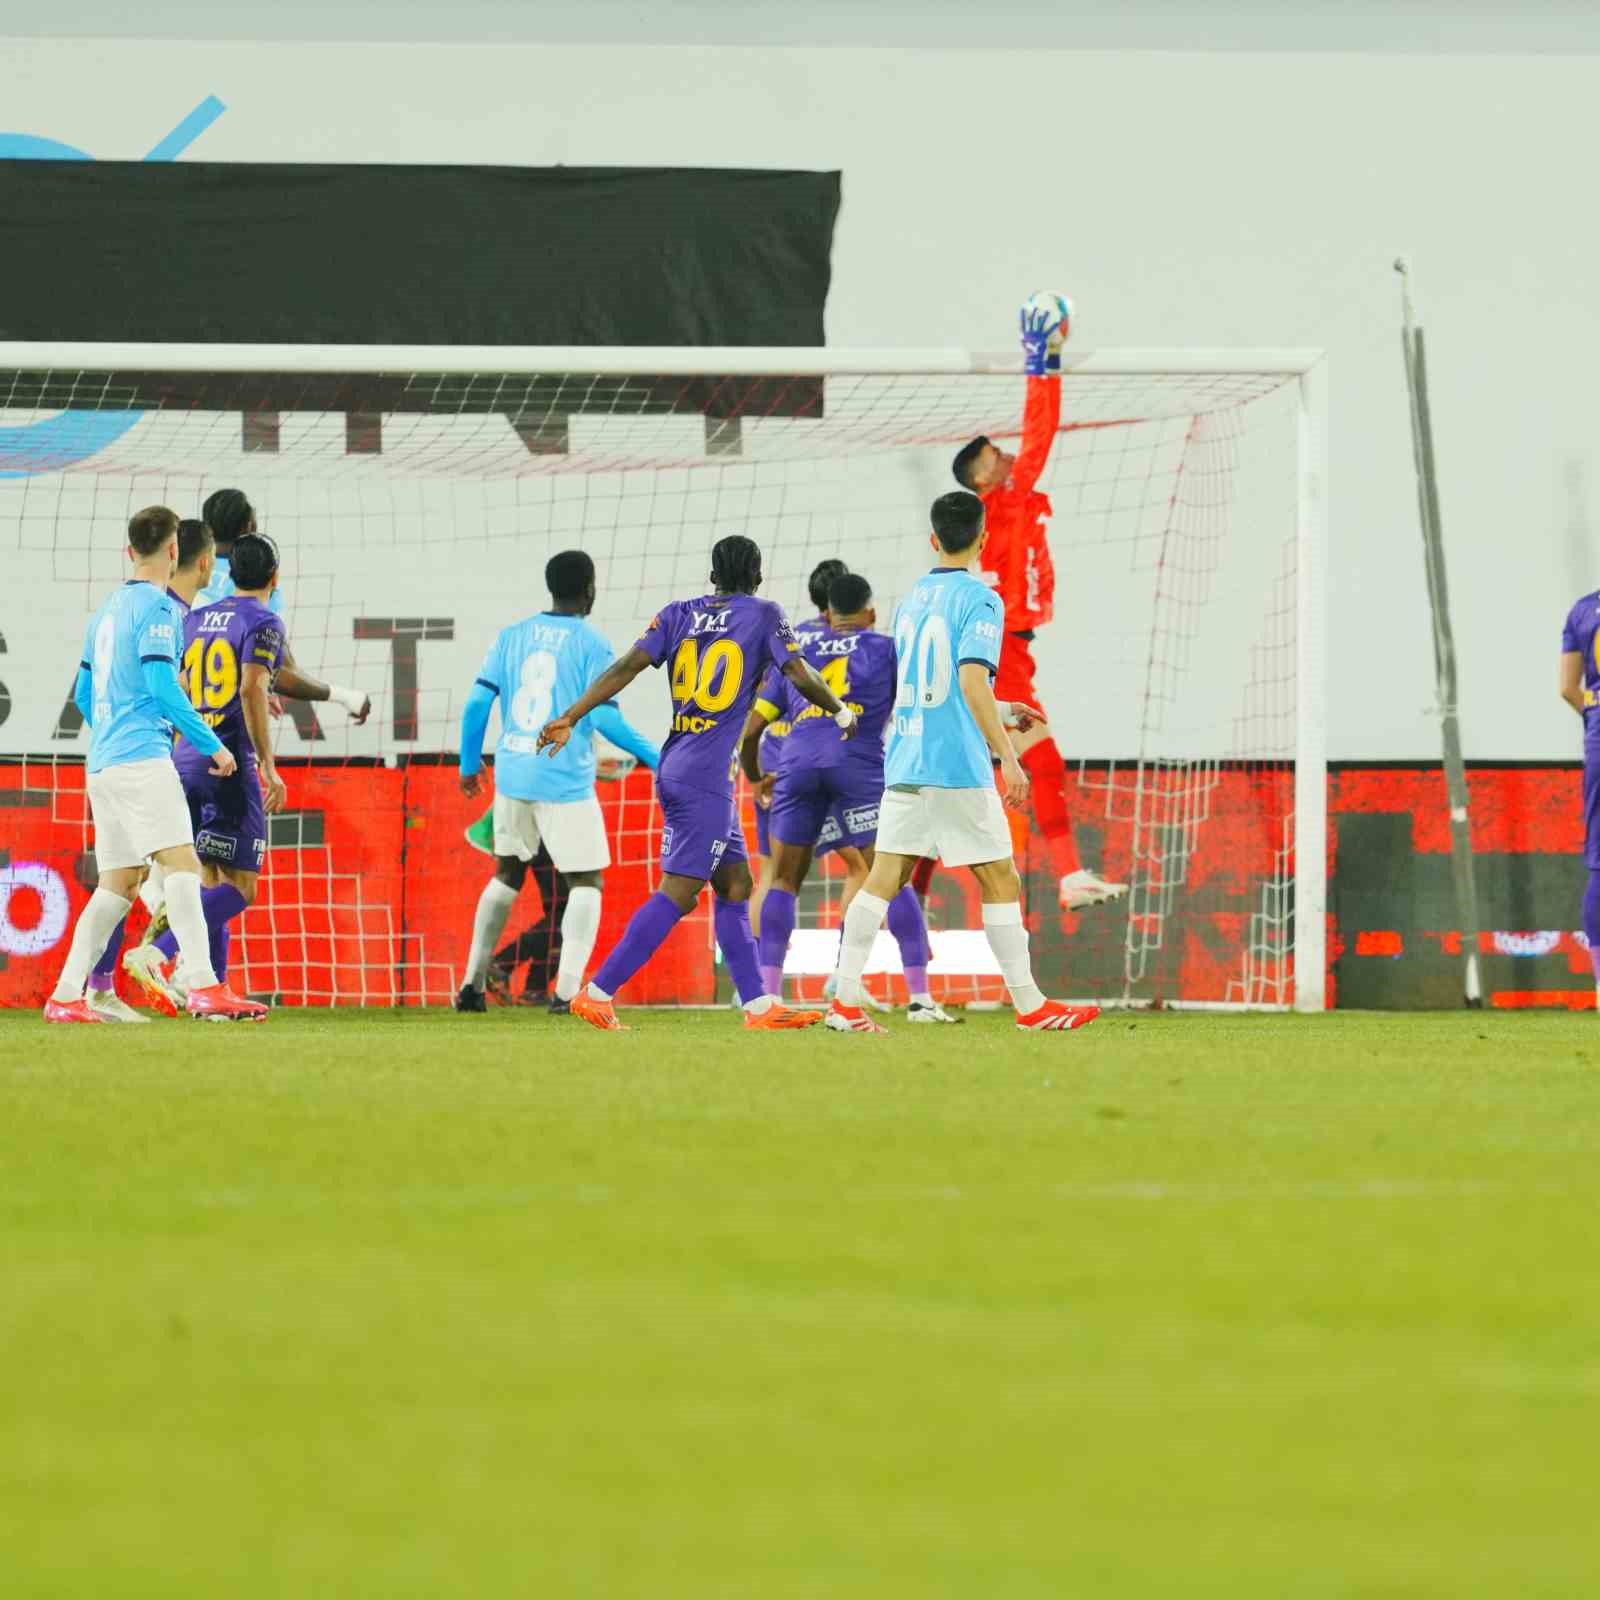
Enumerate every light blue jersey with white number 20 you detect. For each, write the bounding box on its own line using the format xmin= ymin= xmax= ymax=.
xmin=883 ymin=566 xmax=1005 ymax=789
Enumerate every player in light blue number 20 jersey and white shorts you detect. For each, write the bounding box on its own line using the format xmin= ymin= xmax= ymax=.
xmin=827 ymin=490 xmax=1099 ymax=1034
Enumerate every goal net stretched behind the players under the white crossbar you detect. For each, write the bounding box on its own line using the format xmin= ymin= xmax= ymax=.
xmin=0 ymin=346 xmax=1326 ymax=1006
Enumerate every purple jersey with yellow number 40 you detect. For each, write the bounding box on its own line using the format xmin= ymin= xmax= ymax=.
xmin=638 ymin=595 xmax=800 ymax=800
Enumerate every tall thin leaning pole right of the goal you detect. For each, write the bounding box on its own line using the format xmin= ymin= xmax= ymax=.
xmin=1395 ymin=256 xmax=1483 ymax=1006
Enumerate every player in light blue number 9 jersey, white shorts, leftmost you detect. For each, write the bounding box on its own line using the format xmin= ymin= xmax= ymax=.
xmin=45 ymin=506 xmax=267 ymax=1022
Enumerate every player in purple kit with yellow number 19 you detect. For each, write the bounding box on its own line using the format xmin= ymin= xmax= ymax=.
xmin=126 ymin=533 xmax=288 ymax=998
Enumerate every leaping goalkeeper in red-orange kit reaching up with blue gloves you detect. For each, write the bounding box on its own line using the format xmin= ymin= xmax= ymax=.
xmin=952 ymin=304 xmax=1128 ymax=910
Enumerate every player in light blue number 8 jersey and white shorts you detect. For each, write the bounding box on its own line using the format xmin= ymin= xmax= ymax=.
xmin=456 ymin=550 xmax=661 ymax=1013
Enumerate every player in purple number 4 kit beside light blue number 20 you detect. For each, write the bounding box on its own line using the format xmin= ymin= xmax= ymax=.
xmin=739 ymin=573 xmax=960 ymax=1022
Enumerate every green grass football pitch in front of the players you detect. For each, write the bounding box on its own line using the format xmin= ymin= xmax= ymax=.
xmin=0 ymin=1011 xmax=1600 ymax=1600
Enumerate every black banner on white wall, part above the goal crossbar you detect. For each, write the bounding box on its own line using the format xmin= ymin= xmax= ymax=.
xmin=0 ymin=160 xmax=840 ymax=346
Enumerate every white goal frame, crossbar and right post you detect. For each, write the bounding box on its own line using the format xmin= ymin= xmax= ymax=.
xmin=0 ymin=341 xmax=1328 ymax=1011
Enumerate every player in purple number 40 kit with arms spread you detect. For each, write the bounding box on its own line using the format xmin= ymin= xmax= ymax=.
xmin=539 ymin=534 xmax=854 ymax=1030
